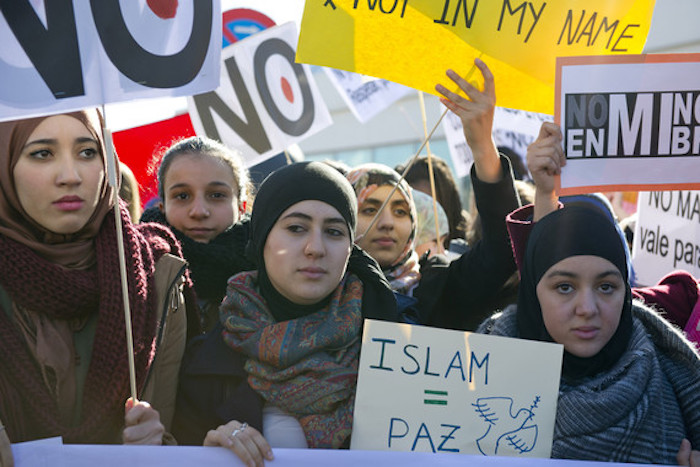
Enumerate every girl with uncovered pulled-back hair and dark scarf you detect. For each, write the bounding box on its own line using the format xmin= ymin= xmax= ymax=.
xmin=141 ymin=136 xmax=254 ymax=337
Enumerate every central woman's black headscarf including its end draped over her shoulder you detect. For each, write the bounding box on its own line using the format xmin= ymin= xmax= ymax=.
xmin=248 ymin=162 xmax=397 ymax=321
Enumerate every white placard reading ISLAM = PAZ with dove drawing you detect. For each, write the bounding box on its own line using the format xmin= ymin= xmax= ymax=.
xmin=350 ymin=320 xmax=563 ymax=457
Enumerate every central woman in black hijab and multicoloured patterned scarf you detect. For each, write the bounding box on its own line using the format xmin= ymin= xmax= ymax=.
xmin=173 ymin=162 xmax=398 ymax=462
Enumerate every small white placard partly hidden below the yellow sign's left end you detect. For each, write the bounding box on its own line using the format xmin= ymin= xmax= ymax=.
xmin=324 ymin=67 xmax=415 ymax=123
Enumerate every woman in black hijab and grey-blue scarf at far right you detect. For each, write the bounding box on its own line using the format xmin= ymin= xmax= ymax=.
xmin=479 ymin=206 xmax=700 ymax=465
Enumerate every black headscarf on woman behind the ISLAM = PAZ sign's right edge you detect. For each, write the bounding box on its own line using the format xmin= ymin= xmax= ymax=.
xmin=517 ymin=206 xmax=632 ymax=379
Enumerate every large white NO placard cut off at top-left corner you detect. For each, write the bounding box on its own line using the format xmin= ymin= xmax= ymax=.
xmin=0 ymin=0 xmax=221 ymax=120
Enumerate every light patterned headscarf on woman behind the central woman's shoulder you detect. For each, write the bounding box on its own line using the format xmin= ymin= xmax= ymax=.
xmin=347 ymin=164 xmax=420 ymax=293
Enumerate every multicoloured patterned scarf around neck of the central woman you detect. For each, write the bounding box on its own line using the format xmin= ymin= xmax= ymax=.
xmin=220 ymin=271 xmax=363 ymax=448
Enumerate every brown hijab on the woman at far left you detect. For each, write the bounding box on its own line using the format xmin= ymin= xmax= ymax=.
xmin=0 ymin=109 xmax=118 ymax=269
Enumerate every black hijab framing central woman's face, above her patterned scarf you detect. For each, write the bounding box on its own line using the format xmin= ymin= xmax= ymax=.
xmin=247 ymin=162 xmax=357 ymax=321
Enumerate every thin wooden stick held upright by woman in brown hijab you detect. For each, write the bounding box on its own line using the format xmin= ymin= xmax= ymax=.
xmin=102 ymin=125 xmax=138 ymax=403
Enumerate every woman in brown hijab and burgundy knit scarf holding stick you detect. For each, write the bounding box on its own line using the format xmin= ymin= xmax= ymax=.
xmin=0 ymin=110 xmax=190 ymax=465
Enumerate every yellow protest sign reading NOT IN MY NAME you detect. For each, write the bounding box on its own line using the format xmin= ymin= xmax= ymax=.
xmin=297 ymin=0 xmax=654 ymax=114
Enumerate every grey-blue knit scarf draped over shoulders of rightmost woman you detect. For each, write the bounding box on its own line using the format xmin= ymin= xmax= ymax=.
xmin=477 ymin=303 xmax=700 ymax=465
